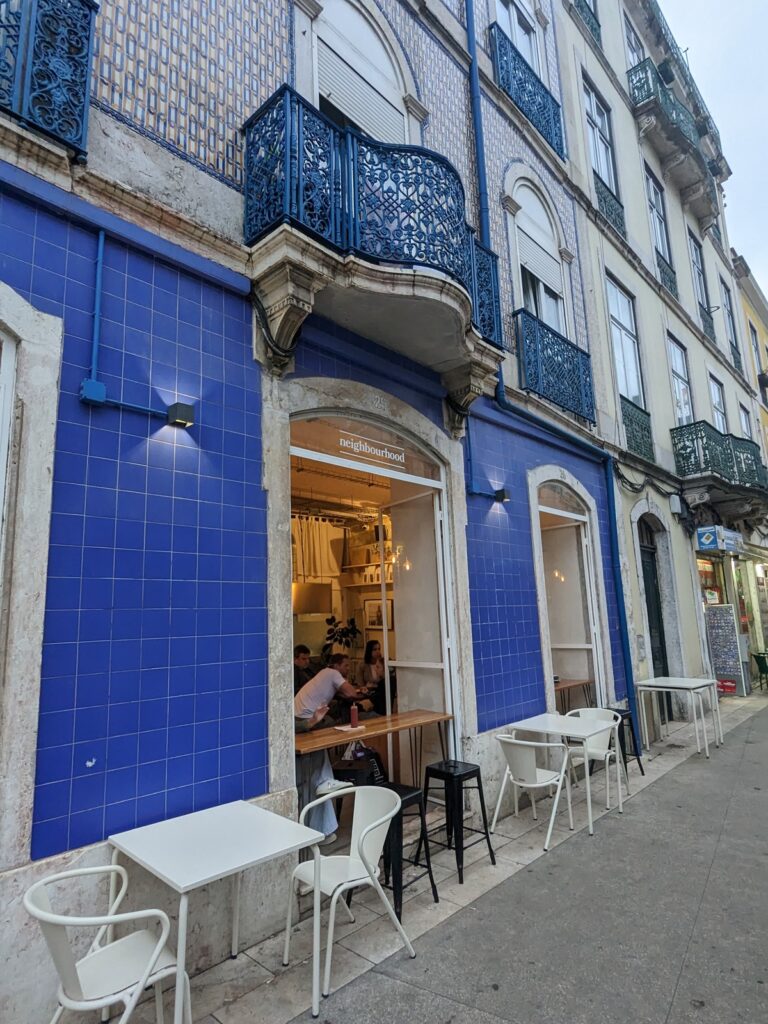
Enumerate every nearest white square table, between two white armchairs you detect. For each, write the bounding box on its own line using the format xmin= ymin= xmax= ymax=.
xmin=109 ymin=800 xmax=324 ymax=1024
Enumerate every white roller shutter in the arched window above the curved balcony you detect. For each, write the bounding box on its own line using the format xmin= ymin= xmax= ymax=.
xmin=317 ymin=39 xmax=406 ymax=142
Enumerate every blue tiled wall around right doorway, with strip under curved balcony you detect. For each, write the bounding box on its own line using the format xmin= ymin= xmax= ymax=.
xmin=296 ymin=319 xmax=626 ymax=731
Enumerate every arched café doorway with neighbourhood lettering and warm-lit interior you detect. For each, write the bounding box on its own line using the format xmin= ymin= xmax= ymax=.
xmin=290 ymin=412 xmax=458 ymax=782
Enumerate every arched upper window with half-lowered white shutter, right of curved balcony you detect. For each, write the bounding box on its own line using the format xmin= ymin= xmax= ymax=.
xmin=514 ymin=184 xmax=565 ymax=334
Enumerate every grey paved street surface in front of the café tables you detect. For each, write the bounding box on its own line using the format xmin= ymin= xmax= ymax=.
xmin=297 ymin=710 xmax=768 ymax=1024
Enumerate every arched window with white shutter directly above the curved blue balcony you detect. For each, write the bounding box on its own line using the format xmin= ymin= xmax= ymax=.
xmin=316 ymin=0 xmax=408 ymax=142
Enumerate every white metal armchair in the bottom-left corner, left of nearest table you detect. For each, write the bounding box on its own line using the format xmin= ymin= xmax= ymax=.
xmin=24 ymin=864 xmax=191 ymax=1024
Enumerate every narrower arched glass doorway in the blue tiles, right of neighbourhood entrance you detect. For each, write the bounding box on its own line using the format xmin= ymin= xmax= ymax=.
xmin=537 ymin=480 xmax=608 ymax=709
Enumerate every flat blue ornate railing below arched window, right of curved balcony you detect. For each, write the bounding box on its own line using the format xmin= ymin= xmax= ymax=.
xmin=512 ymin=309 xmax=595 ymax=423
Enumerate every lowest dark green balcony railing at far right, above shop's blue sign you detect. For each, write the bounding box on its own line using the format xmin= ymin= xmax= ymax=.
xmin=671 ymin=420 xmax=768 ymax=490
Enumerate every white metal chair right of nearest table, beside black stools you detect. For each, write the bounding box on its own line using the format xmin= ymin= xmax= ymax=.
xmin=283 ymin=785 xmax=416 ymax=995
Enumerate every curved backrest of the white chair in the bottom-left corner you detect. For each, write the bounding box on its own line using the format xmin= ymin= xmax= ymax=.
xmin=24 ymin=865 xmax=128 ymax=999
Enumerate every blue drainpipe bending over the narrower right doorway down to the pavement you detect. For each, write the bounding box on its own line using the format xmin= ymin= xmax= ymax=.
xmin=496 ymin=376 xmax=642 ymax=754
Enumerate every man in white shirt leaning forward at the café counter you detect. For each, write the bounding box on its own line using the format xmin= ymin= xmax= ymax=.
xmin=293 ymin=654 xmax=359 ymax=843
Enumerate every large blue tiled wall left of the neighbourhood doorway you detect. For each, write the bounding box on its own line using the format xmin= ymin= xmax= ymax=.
xmin=0 ymin=194 xmax=267 ymax=858
